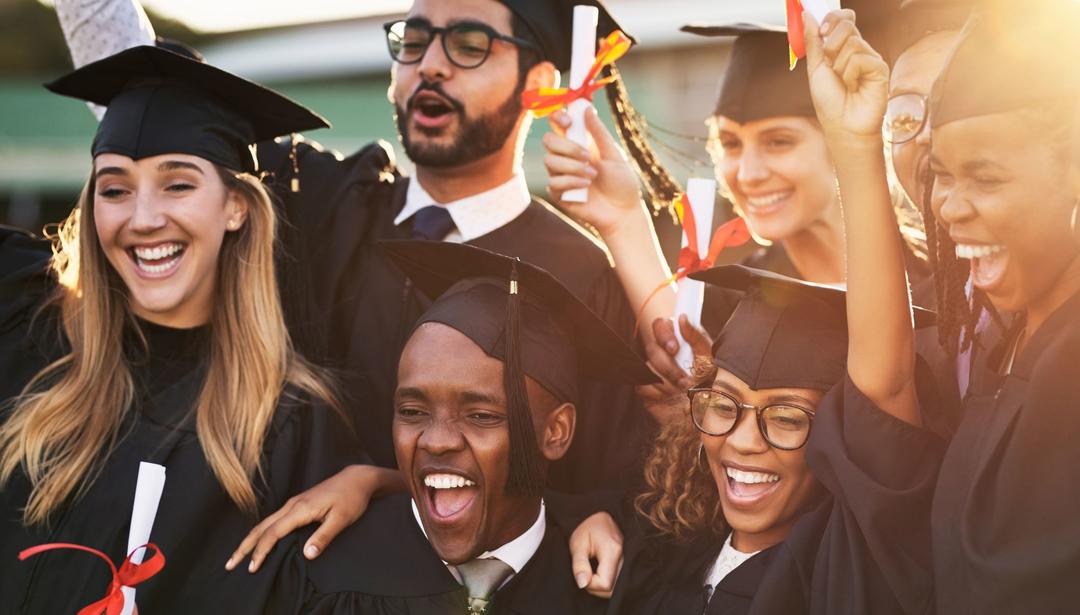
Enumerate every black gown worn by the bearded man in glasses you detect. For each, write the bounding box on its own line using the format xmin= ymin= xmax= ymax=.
xmin=259 ymin=143 xmax=654 ymax=492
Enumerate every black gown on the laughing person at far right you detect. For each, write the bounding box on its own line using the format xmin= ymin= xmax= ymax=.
xmin=932 ymin=294 xmax=1080 ymax=615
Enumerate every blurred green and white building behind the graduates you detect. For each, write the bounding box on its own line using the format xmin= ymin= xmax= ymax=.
xmin=0 ymin=0 xmax=783 ymax=241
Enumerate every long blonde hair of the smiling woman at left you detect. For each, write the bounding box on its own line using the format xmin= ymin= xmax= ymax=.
xmin=0 ymin=168 xmax=336 ymax=525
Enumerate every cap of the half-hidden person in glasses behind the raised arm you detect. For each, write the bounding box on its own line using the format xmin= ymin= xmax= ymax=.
xmin=840 ymin=0 xmax=975 ymax=66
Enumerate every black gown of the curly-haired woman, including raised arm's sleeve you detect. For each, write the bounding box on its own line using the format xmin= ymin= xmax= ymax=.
xmin=609 ymin=375 xmax=943 ymax=615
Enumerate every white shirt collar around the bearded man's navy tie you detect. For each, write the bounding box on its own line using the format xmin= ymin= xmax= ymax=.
xmin=394 ymin=172 xmax=532 ymax=243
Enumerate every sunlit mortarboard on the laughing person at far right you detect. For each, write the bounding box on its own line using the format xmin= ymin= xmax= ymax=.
xmin=930 ymin=0 xmax=1080 ymax=128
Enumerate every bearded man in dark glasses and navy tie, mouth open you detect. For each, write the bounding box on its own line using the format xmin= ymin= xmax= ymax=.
xmin=56 ymin=0 xmax=653 ymax=492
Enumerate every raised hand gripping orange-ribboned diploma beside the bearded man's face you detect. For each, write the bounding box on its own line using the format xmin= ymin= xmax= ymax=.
xmin=543 ymin=109 xmax=645 ymax=237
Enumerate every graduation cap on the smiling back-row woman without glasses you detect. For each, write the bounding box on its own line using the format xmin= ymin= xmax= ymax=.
xmin=681 ymin=24 xmax=818 ymax=124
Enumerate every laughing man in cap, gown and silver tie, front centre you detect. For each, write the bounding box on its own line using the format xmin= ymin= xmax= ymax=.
xmin=265 ymin=241 xmax=657 ymax=615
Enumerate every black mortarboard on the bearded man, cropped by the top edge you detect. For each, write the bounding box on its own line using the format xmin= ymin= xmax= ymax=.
xmin=500 ymin=0 xmax=634 ymax=72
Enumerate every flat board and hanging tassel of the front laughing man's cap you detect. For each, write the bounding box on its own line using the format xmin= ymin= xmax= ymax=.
xmin=379 ymin=240 xmax=659 ymax=494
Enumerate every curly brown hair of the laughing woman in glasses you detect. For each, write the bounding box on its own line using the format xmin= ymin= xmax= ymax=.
xmin=634 ymin=358 xmax=728 ymax=542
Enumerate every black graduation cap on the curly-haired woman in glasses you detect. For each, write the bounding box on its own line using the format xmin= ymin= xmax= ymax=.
xmin=690 ymin=265 xmax=934 ymax=391
